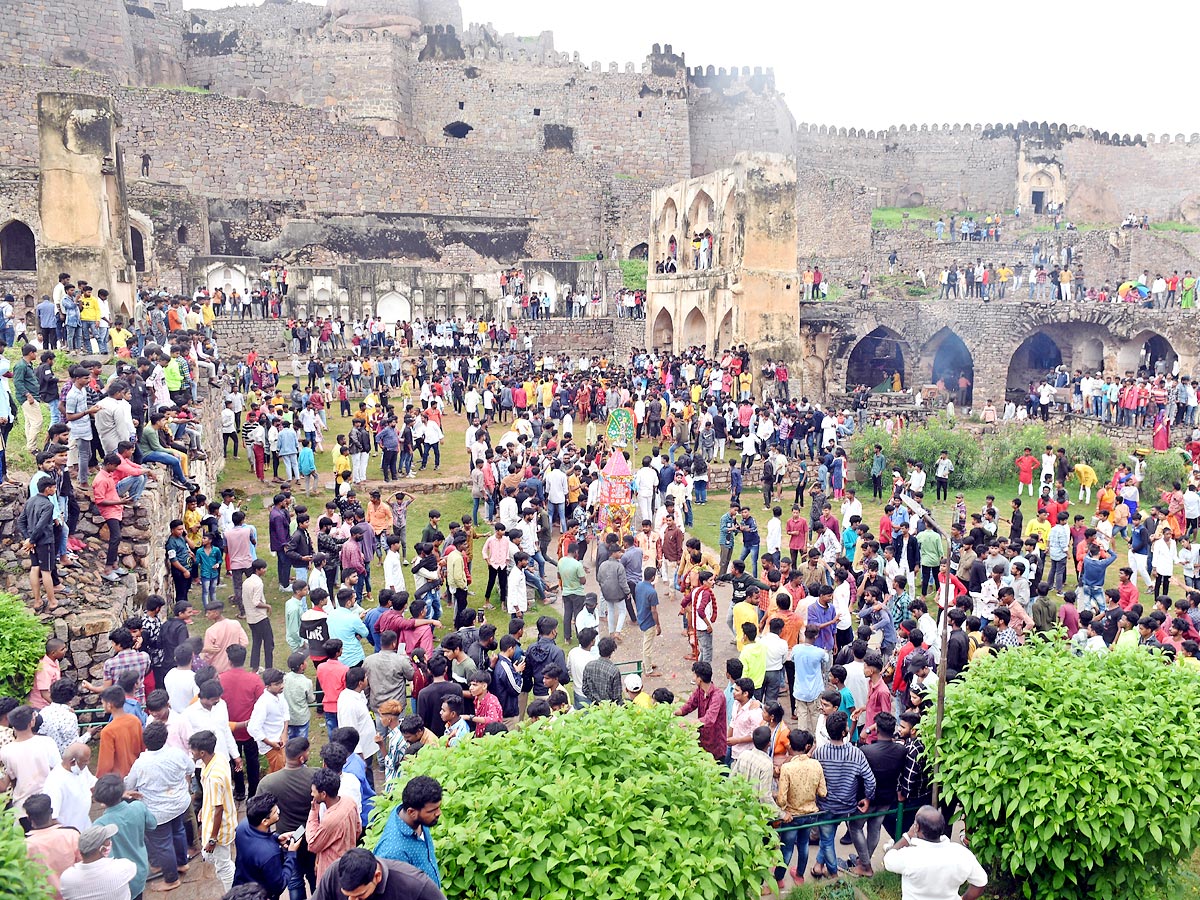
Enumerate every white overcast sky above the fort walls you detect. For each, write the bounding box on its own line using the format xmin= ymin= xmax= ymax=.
xmin=184 ymin=0 xmax=1200 ymax=134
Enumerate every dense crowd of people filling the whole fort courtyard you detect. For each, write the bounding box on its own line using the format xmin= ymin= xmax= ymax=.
xmin=7 ymin=270 xmax=1200 ymax=900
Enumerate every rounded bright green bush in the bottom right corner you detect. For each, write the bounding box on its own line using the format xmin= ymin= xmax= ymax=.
xmin=936 ymin=641 xmax=1200 ymax=900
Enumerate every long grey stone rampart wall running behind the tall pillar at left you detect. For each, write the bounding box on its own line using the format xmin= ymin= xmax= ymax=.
xmin=0 ymin=66 xmax=606 ymax=256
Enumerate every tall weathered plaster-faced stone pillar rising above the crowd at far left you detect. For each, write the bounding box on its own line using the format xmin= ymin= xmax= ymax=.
xmin=37 ymin=92 xmax=134 ymax=317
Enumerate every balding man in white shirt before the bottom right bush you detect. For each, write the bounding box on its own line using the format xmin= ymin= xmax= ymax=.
xmin=883 ymin=806 xmax=988 ymax=900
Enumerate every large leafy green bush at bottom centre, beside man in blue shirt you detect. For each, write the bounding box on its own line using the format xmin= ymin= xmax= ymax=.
xmin=365 ymin=704 xmax=780 ymax=900
